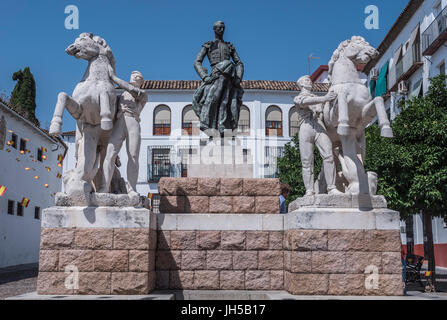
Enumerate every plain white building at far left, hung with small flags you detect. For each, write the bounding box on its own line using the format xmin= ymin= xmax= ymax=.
xmin=0 ymin=101 xmax=66 ymax=268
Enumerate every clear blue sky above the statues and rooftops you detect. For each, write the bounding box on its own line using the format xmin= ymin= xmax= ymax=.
xmin=0 ymin=0 xmax=408 ymax=130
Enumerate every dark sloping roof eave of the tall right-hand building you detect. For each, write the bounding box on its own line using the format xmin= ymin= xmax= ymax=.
xmin=363 ymin=0 xmax=424 ymax=74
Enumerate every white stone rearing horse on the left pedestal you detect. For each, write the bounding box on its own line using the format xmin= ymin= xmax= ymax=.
xmin=49 ymin=33 xmax=139 ymax=196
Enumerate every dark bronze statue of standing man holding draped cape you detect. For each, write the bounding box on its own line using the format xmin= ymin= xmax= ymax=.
xmin=192 ymin=21 xmax=244 ymax=135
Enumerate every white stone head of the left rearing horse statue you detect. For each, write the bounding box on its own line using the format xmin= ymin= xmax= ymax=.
xmin=65 ymin=32 xmax=115 ymax=67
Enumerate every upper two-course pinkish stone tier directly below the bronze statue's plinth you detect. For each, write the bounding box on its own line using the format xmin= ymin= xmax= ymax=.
xmin=158 ymin=178 xmax=280 ymax=213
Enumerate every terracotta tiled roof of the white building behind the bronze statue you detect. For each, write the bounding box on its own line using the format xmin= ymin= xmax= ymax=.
xmin=141 ymin=80 xmax=328 ymax=92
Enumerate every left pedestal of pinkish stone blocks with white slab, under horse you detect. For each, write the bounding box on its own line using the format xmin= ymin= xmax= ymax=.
xmin=37 ymin=207 xmax=157 ymax=295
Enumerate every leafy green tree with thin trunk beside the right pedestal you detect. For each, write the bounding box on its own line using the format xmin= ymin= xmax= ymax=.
xmin=365 ymin=75 xmax=447 ymax=285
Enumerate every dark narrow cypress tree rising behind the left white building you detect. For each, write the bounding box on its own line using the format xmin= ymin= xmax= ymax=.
xmin=9 ymin=67 xmax=39 ymax=125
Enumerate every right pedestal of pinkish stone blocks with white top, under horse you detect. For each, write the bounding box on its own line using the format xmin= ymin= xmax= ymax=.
xmin=284 ymin=195 xmax=403 ymax=296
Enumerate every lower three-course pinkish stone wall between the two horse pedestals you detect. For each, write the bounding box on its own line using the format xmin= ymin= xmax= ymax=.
xmin=156 ymin=230 xmax=284 ymax=290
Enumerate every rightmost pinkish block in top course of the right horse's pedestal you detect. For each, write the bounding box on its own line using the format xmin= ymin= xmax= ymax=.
xmin=365 ymin=230 xmax=402 ymax=252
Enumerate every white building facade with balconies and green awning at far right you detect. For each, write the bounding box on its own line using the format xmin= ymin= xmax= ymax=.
xmin=364 ymin=0 xmax=447 ymax=267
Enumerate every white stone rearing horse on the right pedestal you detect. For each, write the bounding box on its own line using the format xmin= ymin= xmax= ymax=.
xmin=323 ymin=36 xmax=393 ymax=194
